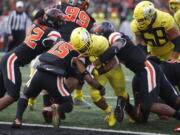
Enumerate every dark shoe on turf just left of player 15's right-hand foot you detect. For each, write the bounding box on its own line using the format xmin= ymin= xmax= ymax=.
xmin=42 ymin=107 xmax=52 ymax=123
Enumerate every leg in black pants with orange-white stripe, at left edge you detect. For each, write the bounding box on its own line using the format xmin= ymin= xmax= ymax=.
xmin=0 ymin=53 xmax=21 ymax=110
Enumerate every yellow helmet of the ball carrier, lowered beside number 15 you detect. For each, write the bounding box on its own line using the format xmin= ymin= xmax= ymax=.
xmin=70 ymin=27 xmax=91 ymax=56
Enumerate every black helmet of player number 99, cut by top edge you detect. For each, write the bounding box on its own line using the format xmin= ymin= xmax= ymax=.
xmin=72 ymin=0 xmax=89 ymax=10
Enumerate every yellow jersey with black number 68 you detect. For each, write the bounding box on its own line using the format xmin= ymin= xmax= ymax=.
xmin=131 ymin=10 xmax=175 ymax=60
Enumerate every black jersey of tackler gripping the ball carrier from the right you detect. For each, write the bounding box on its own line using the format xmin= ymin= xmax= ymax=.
xmin=100 ymin=32 xmax=146 ymax=73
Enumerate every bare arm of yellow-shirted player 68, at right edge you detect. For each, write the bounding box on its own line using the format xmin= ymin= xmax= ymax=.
xmin=167 ymin=26 xmax=180 ymax=59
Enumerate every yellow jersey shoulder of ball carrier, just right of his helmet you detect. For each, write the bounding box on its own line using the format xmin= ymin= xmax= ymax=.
xmin=89 ymin=34 xmax=109 ymax=57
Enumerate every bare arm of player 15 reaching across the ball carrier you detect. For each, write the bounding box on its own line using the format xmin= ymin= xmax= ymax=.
xmin=73 ymin=58 xmax=105 ymax=96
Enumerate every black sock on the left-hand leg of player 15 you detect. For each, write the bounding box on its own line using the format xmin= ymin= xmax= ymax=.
xmin=16 ymin=98 xmax=28 ymax=120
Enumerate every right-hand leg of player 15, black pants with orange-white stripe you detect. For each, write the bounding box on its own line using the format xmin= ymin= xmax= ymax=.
xmin=45 ymin=76 xmax=78 ymax=127
